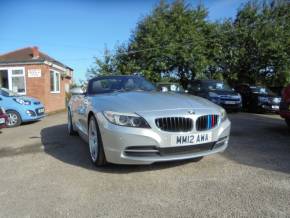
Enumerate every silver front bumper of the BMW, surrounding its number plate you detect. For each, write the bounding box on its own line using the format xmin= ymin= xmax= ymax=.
xmin=98 ymin=115 xmax=231 ymax=164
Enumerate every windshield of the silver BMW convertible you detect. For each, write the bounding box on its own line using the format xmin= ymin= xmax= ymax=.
xmin=89 ymin=76 xmax=156 ymax=94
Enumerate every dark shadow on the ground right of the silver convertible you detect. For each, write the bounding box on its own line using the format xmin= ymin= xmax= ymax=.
xmin=223 ymin=113 xmax=290 ymax=173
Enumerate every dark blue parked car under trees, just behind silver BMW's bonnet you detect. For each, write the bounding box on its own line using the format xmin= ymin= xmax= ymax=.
xmin=188 ymin=80 xmax=242 ymax=111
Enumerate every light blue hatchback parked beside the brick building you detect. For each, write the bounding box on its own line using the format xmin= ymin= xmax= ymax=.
xmin=0 ymin=88 xmax=44 ymax=127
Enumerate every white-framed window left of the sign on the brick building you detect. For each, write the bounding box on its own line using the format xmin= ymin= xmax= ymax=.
xmin=11 ymin=69 xmax=26 ymax=94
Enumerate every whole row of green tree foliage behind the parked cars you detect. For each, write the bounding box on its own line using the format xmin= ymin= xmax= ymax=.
xmin=89 ymin=0 xmax=290 ymax=86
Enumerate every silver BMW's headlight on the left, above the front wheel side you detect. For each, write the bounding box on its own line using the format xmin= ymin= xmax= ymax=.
xmin=103 ymin=111 xmax=150 ymax=128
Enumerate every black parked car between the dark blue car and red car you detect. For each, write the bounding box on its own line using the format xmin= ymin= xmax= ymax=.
xmin=235 ymin=84 xmax=281 ymax=113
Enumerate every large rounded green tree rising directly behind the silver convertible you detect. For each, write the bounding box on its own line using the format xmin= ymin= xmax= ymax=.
xmin=129 ymin=0 xmax=207 ymax=85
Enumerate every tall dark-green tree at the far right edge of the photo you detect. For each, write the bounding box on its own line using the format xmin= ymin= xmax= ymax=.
xmin=234 ymin=1 xmax=290 ymax=86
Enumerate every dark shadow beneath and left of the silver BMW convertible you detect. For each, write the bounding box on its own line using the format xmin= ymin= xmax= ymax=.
xmin=41 ymin=124 xmax=198 ymax=173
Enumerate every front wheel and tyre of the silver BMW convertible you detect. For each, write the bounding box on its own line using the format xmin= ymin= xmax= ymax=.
xmin=88 ymin=116 xmax=107 ymax=166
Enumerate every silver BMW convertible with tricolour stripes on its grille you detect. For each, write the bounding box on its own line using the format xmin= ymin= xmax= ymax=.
xmin=68 ymin=76 xmax=231 ymax=166
